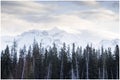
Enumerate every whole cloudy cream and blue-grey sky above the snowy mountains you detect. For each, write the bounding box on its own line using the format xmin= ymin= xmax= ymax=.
xmin=1 ymin=1 xmax=119 ymax=39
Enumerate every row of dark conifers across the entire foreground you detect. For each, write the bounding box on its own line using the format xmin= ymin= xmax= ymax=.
xmin=1 ymin=40 xmax=119 ymax=79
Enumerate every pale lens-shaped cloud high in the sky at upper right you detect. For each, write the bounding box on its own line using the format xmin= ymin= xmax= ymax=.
xmin=73 ymin=9 xmax=119 ymax=22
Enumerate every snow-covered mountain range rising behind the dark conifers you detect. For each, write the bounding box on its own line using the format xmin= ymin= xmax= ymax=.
xmin=0 ymin=27 xmax=120 ymax=51
